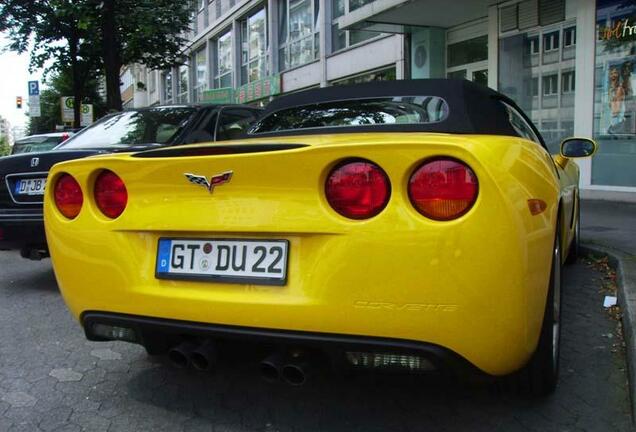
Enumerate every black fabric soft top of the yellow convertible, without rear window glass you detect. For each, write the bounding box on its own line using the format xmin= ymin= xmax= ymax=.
xmin=249 ymin=79 xmax=539 ymax=136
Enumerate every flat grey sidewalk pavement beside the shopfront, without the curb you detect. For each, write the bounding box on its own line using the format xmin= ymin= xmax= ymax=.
xmin=581 ymin=200 xmax=636 ymax=257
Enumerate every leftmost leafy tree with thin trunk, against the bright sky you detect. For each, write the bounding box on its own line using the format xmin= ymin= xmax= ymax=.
xmin=0 ymin=0 xmax=101 ymax=127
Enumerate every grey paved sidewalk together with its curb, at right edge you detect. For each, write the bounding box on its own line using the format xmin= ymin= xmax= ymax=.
xmin=581 ymin=200 xmax=636 ymax=419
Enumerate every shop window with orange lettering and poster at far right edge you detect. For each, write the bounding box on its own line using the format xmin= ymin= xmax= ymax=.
xmin=592 ymin=0 xmax=636 ymax=186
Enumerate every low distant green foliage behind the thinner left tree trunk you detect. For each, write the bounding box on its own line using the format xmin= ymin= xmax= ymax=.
xmin=28 ymin=68 xmax=106 ymax=135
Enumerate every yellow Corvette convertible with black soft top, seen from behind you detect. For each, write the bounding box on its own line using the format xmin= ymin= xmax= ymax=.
xmin=45 ymin=80 xmax=596 ymax=394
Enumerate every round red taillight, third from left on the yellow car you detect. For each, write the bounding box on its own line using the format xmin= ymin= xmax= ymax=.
xmin=325 ymin=160 xmax=391 ymax=219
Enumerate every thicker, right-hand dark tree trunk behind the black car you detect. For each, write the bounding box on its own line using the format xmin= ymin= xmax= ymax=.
xmin=102 ymin=0 xmax=122 ymax=111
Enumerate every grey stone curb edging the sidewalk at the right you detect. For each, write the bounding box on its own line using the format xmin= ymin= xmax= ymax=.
xmin=581 ymin=242 xmax=636 ymax=422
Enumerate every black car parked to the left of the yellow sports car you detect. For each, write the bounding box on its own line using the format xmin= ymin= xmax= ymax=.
xmin=0 ymin=105 xmax=260 ymax=259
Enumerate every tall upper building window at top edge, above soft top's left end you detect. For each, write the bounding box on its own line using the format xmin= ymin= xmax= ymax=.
xmin=278 ymin=0 xmax=320 ymax=71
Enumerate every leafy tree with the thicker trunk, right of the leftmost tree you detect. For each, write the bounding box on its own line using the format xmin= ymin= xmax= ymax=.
xmin=93 ymin=0 xmax=195 ymax=111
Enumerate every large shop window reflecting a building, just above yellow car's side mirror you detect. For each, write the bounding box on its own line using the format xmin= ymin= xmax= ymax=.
xmin=499 ymin=23 xmax=576 ymax=154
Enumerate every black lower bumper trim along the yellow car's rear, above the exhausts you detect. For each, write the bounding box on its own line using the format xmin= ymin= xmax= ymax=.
xmin=81 ymin=311 xmax=482 ymax=375
